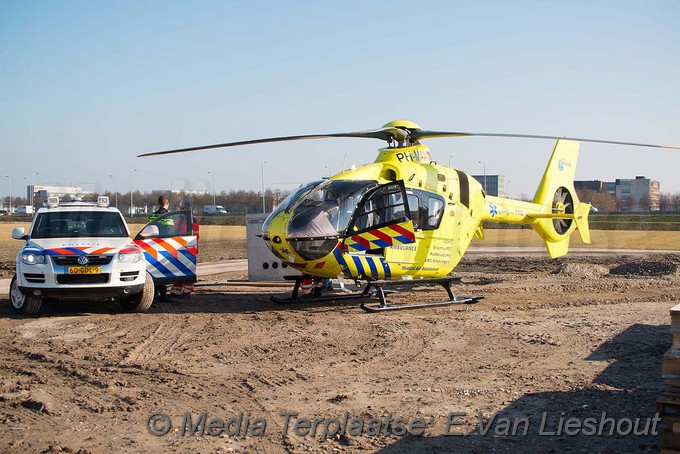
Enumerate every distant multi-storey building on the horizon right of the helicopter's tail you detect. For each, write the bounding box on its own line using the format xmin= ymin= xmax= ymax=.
xmin=574 ymin=176 xmax=661 ymax=211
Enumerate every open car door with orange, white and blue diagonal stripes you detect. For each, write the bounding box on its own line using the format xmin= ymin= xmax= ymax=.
xmin=135 ymin=210 xmax=198 ymax=286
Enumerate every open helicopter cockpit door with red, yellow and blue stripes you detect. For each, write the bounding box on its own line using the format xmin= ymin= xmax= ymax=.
xmin=344 ymin=180 xmax=415 ymax=254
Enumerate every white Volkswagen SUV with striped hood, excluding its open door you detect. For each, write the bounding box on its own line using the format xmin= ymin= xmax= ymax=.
xmin=10 ymin=197 xmax=154 ymax=315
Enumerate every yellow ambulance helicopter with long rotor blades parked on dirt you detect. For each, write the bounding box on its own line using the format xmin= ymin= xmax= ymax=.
xmin=140 ymin=120 xmax=678 ymax=311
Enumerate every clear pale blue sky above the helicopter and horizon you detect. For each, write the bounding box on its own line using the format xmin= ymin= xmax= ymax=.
xmin=0 ymin=0 xmax=680 ymax=197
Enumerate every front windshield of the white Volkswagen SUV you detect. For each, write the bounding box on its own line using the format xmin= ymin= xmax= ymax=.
xmin=31 ymin=211 xmax=128 ymax=238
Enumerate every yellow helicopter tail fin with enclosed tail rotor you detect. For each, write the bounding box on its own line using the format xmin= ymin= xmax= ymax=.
xmin=529 ymin=140 xmax=590 ymax=258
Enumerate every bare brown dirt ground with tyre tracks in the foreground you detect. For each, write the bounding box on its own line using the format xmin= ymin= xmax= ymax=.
xmin=0 ymin=250 xmax=680 ymax=453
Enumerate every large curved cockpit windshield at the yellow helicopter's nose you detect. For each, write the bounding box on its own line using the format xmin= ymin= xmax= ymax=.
xmin=288 ymin=180 xmax=378 ymax=239
